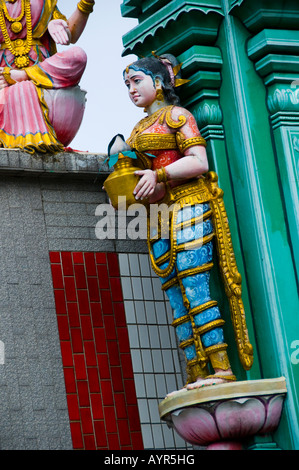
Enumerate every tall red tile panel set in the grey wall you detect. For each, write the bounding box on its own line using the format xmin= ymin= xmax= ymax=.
xmin=50 ymin=251 xmax=143 ymax=450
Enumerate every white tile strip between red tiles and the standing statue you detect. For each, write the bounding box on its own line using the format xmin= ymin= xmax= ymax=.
xmin=119 ymin=254 xmax=189 ymax=449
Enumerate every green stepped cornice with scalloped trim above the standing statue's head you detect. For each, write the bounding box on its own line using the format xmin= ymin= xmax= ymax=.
xmin=121 ymin=0 xmax=223 ymax=56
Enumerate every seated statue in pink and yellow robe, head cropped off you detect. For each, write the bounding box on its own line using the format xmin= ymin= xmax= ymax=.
xmin=0 ymin=0 xmax=94 ymax=153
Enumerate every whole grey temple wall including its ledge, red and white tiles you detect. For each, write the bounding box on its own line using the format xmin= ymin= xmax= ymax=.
xmin=0 ymin=150 xmax=186 ymax=450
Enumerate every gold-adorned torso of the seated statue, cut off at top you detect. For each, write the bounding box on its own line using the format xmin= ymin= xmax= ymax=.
xmin=0 ymin=0 xmax=65 ymax=67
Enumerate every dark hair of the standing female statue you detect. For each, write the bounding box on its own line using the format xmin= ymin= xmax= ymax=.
xmin=124 ymin=54 xmax=180 ymax=105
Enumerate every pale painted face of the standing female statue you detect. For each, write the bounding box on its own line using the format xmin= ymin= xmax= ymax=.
xmin=124 ymin=69 xmax=156 ymax=108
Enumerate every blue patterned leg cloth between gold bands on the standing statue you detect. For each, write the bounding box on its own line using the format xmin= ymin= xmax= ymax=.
xmin=152 ymin=200 xmax=224 ymax=361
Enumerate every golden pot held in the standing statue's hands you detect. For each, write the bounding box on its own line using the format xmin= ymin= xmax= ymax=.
xmin=104 ymin=153 xmax=147 ymax=209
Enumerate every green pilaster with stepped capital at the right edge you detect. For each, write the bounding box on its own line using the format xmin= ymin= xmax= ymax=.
xmin=248 ymin=27 xmax=299 ymax=274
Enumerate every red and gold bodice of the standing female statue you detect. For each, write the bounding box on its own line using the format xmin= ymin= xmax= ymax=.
xmin=127 ymin=106 xmax=205 ymax=170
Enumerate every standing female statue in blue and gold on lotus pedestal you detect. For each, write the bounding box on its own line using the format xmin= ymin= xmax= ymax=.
xmin=108 ymin=55 xmax=252 ymax=390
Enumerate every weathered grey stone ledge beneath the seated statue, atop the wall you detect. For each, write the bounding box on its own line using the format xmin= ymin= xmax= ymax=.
xmin=0 ymin=149 xmax=110 ymax=179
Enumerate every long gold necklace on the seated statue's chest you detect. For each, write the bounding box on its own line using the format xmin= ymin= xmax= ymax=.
xmin=0 ymin=0 xmax=32 ymax=69
